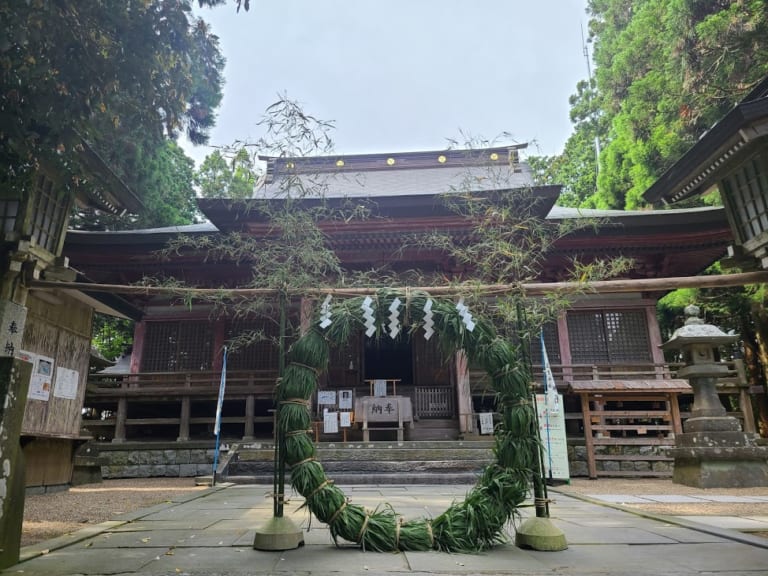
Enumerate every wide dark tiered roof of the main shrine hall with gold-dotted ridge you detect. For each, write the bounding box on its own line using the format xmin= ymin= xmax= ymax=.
xmin=64 ymin=146 xmax=731 ymax=286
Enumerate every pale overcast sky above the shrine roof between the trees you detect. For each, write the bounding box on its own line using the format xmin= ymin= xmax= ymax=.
xmin=182 ymin=0 xmax=591 ymax=163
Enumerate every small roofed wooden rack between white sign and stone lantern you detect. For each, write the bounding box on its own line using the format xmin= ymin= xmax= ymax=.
xmin=569 ymin=379 xmax=691 ymax=478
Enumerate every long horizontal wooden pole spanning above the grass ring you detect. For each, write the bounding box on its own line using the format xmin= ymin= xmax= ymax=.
xmin=28 ymin=270 xmax=768 ymax=299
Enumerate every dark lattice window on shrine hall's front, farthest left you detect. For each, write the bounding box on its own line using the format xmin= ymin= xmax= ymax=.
xmin=141 ymin=321 xmax=213 ymax=372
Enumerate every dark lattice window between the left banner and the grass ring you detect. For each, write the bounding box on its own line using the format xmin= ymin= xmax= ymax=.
xmin=226 ymin=320 xmax=280 ymax=370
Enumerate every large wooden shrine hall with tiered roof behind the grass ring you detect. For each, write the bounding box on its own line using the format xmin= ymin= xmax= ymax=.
xmin=57 ymin=146 xmax=752 ymax=476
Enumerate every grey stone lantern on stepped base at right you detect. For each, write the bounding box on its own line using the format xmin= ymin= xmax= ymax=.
xmin=661 ymin=306 xmax=768 ymax=488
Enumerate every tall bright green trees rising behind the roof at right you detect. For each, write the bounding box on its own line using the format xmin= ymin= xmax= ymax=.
xmin=548 ymin=0 xmax=768 ymax=209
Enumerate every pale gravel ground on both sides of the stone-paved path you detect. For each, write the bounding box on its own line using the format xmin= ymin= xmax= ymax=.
xmin=22 ymin=478 xmax=768 ymax=546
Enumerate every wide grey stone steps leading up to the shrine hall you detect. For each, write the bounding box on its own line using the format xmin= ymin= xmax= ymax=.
xmin=217 ymin=440 xmax=493 ymax=484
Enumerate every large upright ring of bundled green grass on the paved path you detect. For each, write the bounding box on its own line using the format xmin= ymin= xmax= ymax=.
xmin=278 ymin=290 xmax=540 ymax=553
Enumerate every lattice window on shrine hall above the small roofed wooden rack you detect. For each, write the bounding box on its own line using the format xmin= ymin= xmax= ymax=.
xmin=568 ymin=310 xmax=651 ymax=364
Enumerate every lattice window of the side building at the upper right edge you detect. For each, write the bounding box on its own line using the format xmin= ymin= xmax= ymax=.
xmin=723 ymin=152 xmax=768 ymax=243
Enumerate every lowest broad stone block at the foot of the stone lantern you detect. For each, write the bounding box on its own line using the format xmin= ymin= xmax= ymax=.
xmin=672 ymin=458 xmax=768 ymax=488
